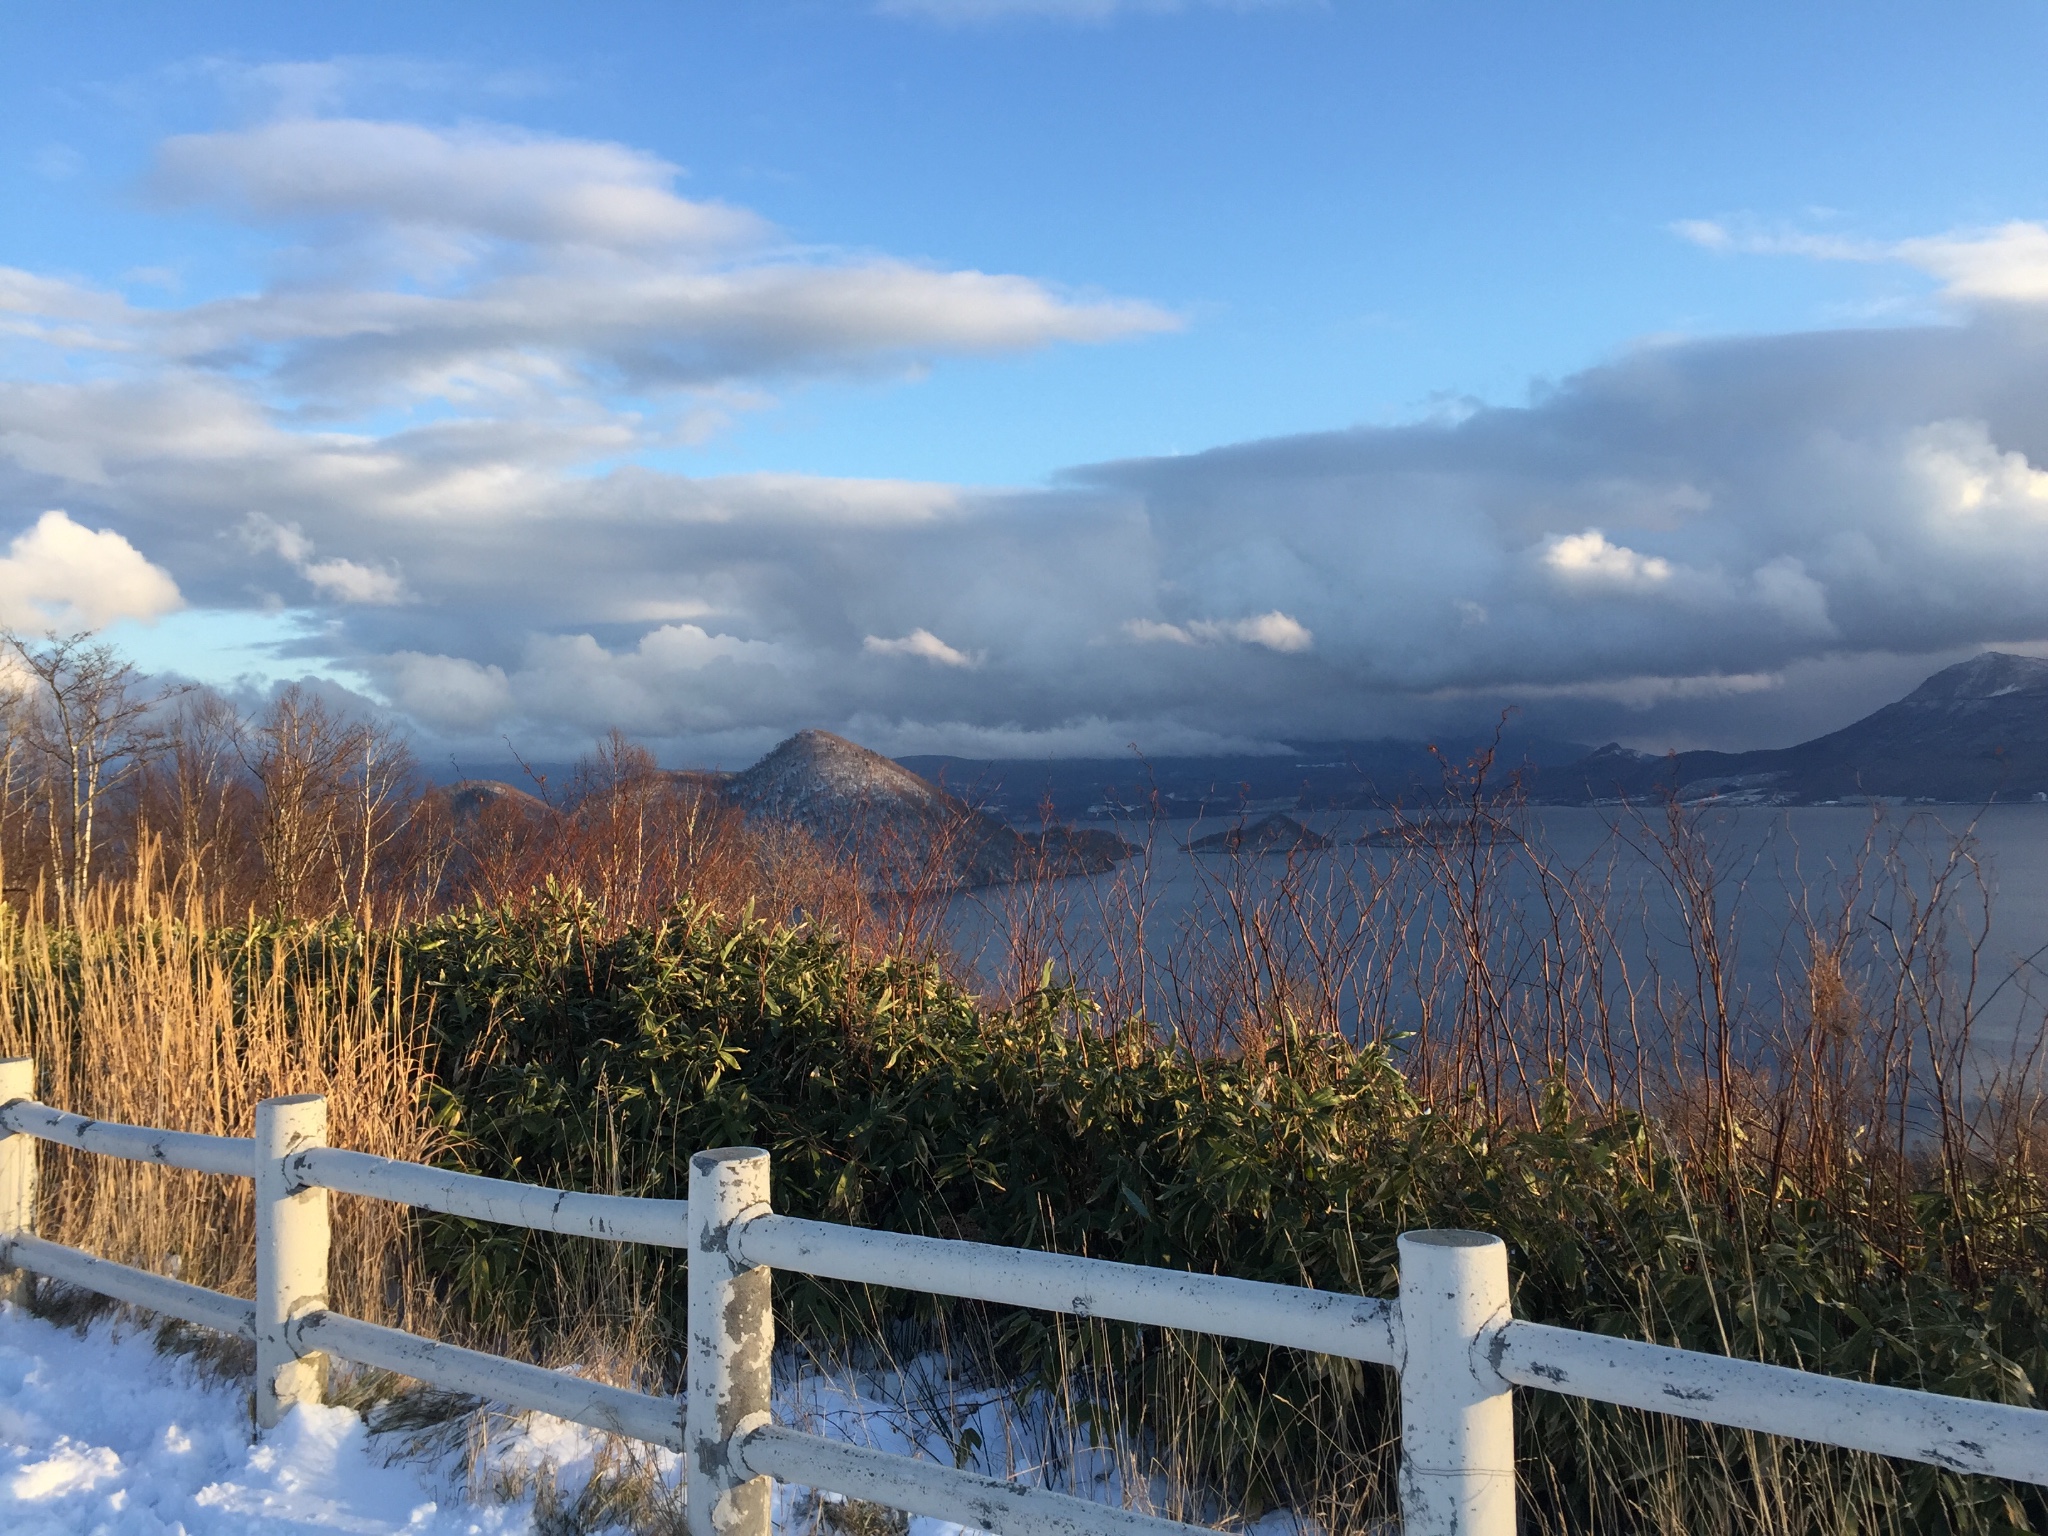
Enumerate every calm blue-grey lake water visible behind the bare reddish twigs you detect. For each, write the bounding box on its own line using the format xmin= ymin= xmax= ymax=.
xmin=948 ymin=805 xmax=2048 ymax=1065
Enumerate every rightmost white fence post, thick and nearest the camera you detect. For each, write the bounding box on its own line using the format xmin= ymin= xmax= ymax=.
xmin=1401 ymin=1231 xmax=1516 ymax=1536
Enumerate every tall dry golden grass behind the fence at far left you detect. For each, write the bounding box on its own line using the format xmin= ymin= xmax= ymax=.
xmin=0 ymin=872 xmax=434 ymax=1321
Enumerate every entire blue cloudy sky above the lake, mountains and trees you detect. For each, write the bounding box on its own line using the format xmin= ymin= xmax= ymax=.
xmin=0 ymin=0 xmax=2048 ymax=766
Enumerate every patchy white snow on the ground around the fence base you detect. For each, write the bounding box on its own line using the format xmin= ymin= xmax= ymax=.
xmin=0 ymin=1305 xmax=1311 ymax=1536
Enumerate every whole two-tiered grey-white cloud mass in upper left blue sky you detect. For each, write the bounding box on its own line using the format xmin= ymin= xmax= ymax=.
xmin=72 ymin=117 xmax=1180 ymax=415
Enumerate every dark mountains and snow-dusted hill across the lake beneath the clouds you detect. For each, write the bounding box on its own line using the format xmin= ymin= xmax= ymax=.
xmin=449 ymin=651 xmax=2048 ymax=885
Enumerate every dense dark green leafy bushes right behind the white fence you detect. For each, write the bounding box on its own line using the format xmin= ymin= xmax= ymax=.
xmin=387 ymin=899 xmax=2048 ymax=1530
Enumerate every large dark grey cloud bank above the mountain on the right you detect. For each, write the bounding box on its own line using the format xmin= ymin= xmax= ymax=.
xmin=1096 ymin=317 xmax=2048 ymax=739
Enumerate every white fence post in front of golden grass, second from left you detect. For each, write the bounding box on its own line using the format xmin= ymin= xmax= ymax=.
xmin=256 ymin=1094 xmax=328 ymax=1430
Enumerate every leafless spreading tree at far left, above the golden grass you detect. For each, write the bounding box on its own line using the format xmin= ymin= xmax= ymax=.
xmin=0 ymin=631 xmax=182 ymax=911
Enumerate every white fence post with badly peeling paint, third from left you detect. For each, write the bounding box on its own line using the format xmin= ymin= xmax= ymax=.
xmin=682 ymin=1147 xmax=774 ymax=1536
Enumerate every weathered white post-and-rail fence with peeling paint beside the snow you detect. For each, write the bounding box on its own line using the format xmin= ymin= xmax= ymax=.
xmin=0 ymin=1059 xmax=2048 ymax=1536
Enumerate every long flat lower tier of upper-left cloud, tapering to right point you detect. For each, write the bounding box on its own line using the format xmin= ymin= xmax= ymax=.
xmin=140 ymin=256 xmax=1176 ymax=406
